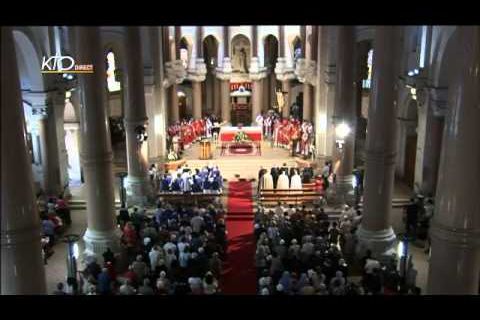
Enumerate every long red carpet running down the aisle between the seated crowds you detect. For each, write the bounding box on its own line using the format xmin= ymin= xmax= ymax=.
xmin=222 ymin=181 xmax=257 ymax=295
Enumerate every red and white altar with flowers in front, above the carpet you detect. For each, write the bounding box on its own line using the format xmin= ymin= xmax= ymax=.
xmin=219 ymin=127 xmax=262 ymax=156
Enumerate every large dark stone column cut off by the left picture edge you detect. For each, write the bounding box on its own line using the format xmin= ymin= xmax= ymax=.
xmin=0 ymin=27 xmax=46 ymax=295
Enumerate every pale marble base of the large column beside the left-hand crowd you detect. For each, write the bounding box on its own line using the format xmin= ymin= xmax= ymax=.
xmin=83 ymin=228 xmax=121 ymax=261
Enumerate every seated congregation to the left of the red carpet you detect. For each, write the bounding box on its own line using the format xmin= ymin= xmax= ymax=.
xmin=80 ymin=203 xmax=227 ymax=295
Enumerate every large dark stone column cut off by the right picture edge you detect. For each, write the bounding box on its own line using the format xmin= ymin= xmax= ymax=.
xmin=427 ymin=26 xmax=480 ymax=295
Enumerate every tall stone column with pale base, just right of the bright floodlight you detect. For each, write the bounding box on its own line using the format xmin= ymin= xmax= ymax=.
xmin=357 ymin=26 xmax=398 ymax=256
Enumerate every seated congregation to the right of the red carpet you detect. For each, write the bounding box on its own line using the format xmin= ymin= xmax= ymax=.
xmin=255 ymin=204 xmax=420 ymax=296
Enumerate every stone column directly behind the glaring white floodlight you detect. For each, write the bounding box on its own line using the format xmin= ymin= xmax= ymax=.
xmin=332 ymin=26 xmax=355 ymax=203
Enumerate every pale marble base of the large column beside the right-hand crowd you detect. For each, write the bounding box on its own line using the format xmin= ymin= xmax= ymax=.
xmin=355 ymin=225 xmax=397 ymax=262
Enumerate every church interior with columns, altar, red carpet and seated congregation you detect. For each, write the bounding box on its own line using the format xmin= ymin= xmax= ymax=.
xmin=1 ymin=25 xmax=480 ymax=296
